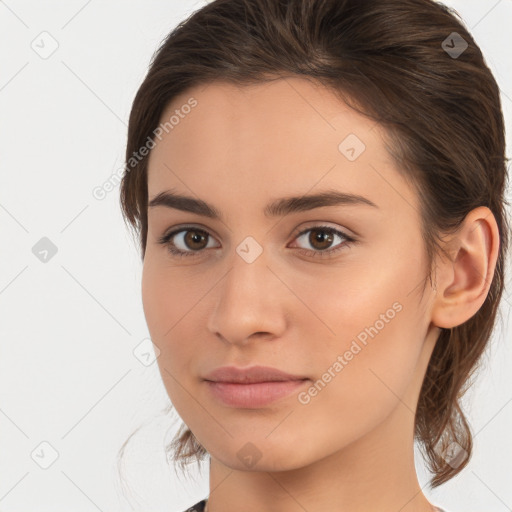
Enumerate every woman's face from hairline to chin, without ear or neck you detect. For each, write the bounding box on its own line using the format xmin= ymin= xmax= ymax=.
xmin=142 ymin=78 xmax=440 ymax=470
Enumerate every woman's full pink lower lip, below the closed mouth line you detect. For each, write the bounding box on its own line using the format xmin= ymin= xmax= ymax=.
xmin=206 ymin=379 xmax=308 ymax=408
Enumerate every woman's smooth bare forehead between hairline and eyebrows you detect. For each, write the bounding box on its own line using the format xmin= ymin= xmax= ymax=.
xmin=148 ymin=77 xmax=414 ymax=217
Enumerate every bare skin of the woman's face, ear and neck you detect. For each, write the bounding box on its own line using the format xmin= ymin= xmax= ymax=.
xmin=142 ymin=77 xmax=499 ymax=512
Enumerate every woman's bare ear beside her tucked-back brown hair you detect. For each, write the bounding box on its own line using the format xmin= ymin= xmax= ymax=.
xmin=432 ymin=206 xmax=500 ymax=329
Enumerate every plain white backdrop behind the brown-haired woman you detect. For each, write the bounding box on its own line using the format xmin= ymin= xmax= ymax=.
xmin=0 ymin=0 xmax=512 ymax=512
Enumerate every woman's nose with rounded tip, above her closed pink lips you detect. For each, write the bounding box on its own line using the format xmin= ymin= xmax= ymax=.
xmin=208 ymin=246 xmax=293 ymax=345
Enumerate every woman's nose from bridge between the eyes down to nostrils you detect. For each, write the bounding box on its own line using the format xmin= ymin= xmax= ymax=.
xmin=208 ymin=237 xmax=285 ymax=343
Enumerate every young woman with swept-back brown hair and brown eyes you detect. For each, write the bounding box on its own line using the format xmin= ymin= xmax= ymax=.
xmin=121 ymin=0 xmax=510 ymax=512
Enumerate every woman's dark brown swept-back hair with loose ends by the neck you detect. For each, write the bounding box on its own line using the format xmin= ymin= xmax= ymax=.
xmin=120 ymin=0 xmax=510 ymax=488
